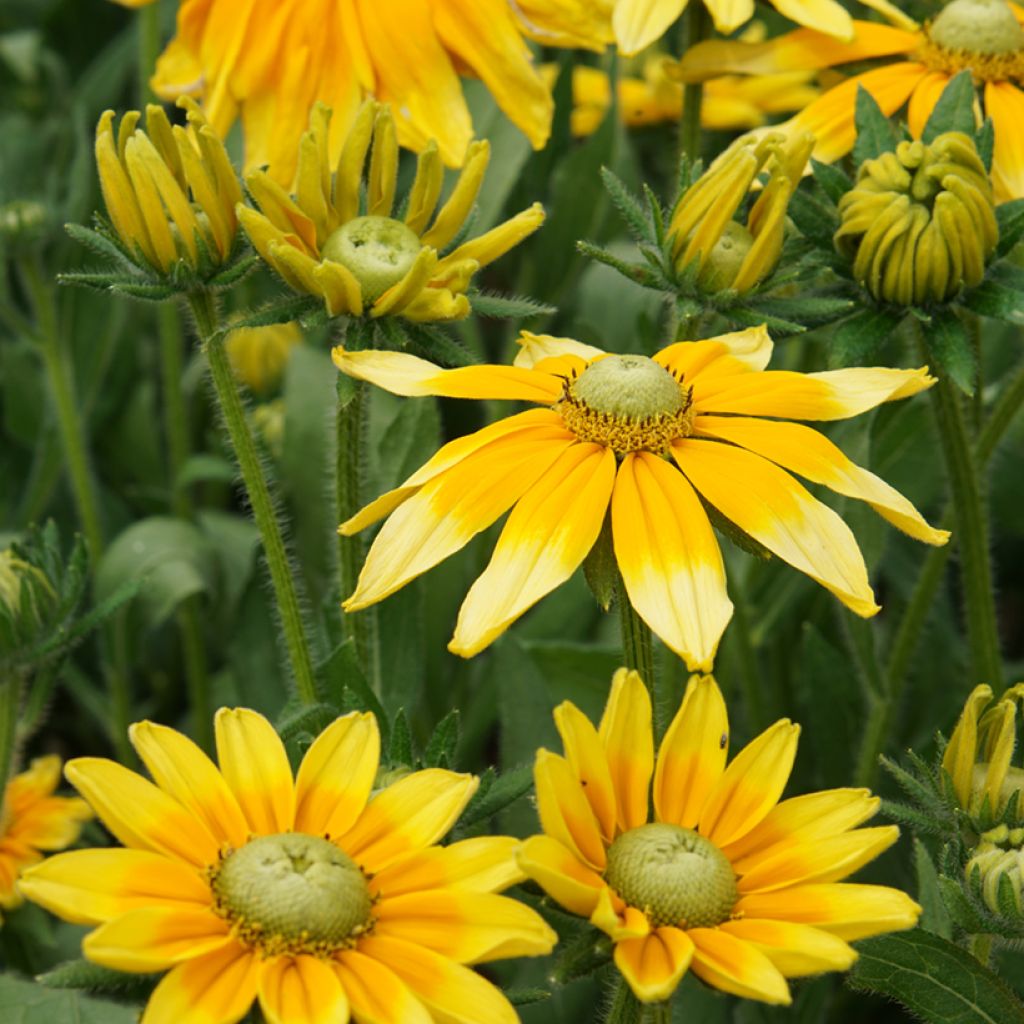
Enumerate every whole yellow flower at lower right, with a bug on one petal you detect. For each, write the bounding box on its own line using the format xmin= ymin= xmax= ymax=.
xmin=518 ymin=669 xmax=921 ymax=1004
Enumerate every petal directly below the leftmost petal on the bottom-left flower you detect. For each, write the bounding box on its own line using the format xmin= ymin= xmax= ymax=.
xmin=82 ymin=906 xmax=231 ymax=972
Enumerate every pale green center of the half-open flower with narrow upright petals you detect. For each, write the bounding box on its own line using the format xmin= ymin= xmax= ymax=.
xmin=321 ymin=217 xmax=423 ymax=302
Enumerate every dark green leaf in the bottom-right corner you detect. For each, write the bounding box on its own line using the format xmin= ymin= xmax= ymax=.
xmin=848 ymin=929 xmax=1024 ymax=1024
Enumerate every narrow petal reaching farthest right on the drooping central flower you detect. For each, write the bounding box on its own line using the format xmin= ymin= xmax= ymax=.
xmin=694 ymin=416 xmax=949 ymax=545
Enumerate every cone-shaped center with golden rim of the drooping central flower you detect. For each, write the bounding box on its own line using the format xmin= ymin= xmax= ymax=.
xmin=558 ymin=355 xmax=692 ymax=455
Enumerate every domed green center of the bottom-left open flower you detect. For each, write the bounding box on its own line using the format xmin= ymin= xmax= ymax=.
xmin=210 ymin=833 xmax=373 ymax=955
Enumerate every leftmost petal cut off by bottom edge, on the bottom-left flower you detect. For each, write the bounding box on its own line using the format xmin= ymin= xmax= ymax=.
xmin=141 ymin=943 xmax=260 ymax=1024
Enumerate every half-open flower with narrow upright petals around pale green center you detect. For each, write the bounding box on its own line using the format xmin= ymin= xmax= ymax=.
xmin=239 ymin=100 xmax=544 ymax=321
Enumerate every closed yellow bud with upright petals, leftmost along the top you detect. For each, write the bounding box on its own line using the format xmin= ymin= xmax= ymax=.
xmin=96 ymin=100 xmax=242 ymax=274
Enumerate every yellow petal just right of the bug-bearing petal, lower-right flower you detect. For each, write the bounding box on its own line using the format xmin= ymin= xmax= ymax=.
xmin=699 ymin=718 xmax=800 ymax=847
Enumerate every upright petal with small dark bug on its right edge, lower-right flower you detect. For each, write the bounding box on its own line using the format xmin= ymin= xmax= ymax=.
xmin=654 ymin=676 xmax=729 ymax=828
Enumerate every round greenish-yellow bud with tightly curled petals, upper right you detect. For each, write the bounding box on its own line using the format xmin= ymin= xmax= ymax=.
xmin=835 ymin=132 xmax=999 ymax=306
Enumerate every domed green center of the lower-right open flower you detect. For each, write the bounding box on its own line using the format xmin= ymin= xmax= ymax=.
xmin=604 ymin=823 xmax=738 ymax=928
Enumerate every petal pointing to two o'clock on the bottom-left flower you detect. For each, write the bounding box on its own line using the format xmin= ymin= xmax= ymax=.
xmin=337 ymin=768 xmax=479 ymax=873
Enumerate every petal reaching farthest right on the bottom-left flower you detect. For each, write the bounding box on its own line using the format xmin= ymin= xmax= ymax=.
xmin=374 ymin=889 xmax=558 ymax=964
